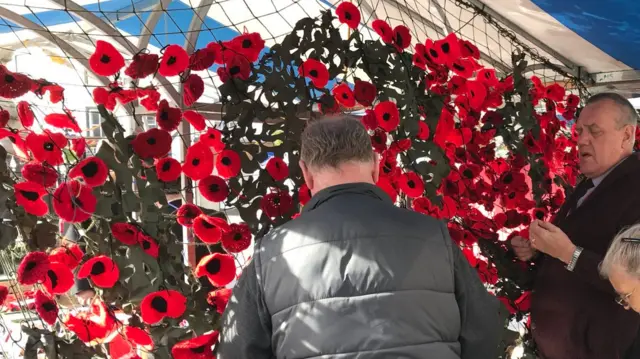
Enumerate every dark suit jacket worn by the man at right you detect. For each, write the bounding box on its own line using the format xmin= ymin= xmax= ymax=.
xmin=531 ymin=153 xmax=640 ymax=359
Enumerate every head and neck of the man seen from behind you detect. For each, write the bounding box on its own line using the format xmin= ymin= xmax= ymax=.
xmin=300 ymin=116 xmax=379 ymax=194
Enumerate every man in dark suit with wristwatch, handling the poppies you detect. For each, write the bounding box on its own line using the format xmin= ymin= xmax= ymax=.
xmin=511 ymin=93 xmax=640 ymax=359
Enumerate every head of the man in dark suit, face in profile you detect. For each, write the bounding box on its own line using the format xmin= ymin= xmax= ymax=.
xmin=576 ymin=92 xmax=638 ymax=178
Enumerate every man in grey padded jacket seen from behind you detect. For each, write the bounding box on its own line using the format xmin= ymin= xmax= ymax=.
xmin=217 ymin=117 xmax=505 ymax=359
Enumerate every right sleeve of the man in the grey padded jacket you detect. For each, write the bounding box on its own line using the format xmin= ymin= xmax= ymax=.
xmin=449 ymin=239 xmax=507 ymax=359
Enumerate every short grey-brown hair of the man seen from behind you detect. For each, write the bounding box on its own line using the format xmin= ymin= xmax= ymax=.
xmin=300 ymin=115 xmax=374 ymax=168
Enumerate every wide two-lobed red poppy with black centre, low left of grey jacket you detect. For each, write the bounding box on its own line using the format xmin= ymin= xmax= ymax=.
xmin=140 ymin=289 xmax=187 ymax=324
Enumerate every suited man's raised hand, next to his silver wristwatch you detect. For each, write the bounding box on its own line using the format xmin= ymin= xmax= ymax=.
xmin=529 ymin=220 xmax=576 ymax=264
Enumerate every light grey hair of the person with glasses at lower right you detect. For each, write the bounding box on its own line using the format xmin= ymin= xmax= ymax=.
xmin=600 ymin=223 xmax=640 ymax=278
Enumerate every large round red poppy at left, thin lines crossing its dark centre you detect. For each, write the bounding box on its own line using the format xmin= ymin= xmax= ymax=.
xmin=53 ymin=181 xmax=98 ymax=223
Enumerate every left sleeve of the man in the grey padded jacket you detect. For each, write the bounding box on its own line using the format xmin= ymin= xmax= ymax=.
xmin=216 ymin=261 xmax=273 ymax=359
